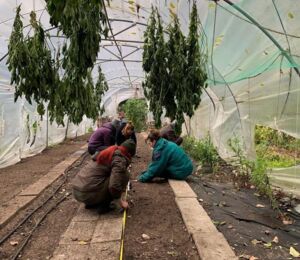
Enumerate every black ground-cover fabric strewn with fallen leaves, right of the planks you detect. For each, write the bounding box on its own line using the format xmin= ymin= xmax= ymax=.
xmin=188 ymin=174 xmax=300 ymax=260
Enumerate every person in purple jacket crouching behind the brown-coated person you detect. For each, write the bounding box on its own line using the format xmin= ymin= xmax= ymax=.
xmin=88 ymin=120 xmax=117 ymax=155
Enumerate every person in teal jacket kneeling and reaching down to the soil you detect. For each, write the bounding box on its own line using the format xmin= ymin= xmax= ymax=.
xmin=138 ymin=130 xmax=193 ymax=182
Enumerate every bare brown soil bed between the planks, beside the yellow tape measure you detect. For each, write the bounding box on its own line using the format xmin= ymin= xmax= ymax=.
xmin=125 ymin=136 xmax=199 ymax=260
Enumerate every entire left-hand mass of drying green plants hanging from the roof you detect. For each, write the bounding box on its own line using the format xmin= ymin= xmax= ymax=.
xmin=7 ymin=3 xmax=108 ymax=124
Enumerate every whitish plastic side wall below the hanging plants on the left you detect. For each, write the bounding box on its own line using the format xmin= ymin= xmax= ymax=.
xmin=0 ymin=93 xmax=94 ymax=168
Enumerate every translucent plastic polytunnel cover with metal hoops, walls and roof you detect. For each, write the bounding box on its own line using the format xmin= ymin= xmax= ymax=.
xmin=0 ymin=0 xmax=300 ymax=193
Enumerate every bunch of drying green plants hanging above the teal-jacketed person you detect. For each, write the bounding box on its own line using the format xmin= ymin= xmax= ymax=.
xmin=143 ymin=3 xmax=207 ymax=133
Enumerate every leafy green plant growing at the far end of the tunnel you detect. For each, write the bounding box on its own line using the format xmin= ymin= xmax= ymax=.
xmin=123 ymin=99 xmax=148 ymax=132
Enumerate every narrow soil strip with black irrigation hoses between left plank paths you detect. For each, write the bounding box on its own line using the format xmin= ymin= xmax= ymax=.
xmin=0 ymin=153 xmax=90 ymax=259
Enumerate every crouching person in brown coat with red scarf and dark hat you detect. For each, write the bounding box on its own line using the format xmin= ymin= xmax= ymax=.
xmin=72 ymin=139 xmax=136 ymax=213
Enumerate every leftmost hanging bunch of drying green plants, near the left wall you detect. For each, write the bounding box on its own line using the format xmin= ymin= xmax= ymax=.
xmin=7 ymin=6 xmax=58 ymax=115
